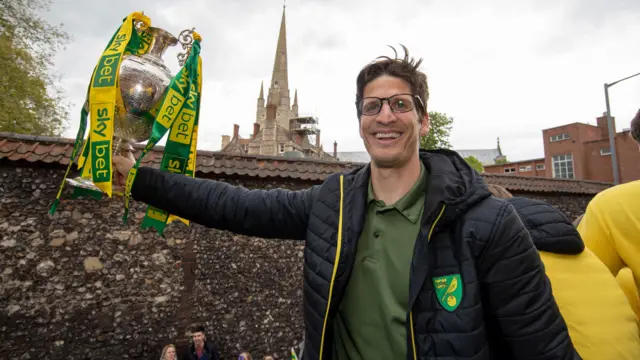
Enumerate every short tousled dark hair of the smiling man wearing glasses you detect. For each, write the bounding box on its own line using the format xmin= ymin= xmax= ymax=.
xmin=356 ymin=45 xmax=429 ymax=118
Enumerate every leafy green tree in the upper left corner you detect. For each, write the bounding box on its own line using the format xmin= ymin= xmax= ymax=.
xmin=0 ymin=0 xmax=69 ymax=136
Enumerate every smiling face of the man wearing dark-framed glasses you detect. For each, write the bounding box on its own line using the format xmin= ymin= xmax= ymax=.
xmin=360 ymin=75 xmax=429 ymax=168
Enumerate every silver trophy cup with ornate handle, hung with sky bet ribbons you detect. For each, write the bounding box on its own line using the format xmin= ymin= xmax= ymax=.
xmin=66 ymin=22 xmax=194 ymax=193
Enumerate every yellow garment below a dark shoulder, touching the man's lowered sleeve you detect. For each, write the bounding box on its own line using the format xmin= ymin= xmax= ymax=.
xmin=540 ymin=249 xmax=640 ymax=360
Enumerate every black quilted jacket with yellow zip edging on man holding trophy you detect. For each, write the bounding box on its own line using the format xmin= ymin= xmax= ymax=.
xmin=132 ymin=150 xmax=579 ymax=360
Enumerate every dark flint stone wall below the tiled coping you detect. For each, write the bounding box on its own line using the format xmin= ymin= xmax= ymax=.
xmin=0 ymin=161 xmax=590 ymax=359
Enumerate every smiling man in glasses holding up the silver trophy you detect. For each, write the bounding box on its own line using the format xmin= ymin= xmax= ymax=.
xmin=116 ymin=48 xmax=578 ymax=360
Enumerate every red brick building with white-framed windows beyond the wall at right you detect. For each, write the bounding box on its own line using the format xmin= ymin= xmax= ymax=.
xmin=484 ymin=115 xmax=640 ymax=183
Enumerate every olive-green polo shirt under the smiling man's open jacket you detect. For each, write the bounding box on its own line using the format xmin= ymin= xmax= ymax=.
xmin=333 ymin=166 xmax=427 ymax=360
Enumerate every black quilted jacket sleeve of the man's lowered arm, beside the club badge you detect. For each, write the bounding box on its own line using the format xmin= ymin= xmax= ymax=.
xmin=479 ymin=202 xmax=580 ymax=360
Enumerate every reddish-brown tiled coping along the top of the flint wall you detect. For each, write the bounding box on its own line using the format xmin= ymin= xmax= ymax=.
xmin=0 ymin=132 xmax=611 ymax=194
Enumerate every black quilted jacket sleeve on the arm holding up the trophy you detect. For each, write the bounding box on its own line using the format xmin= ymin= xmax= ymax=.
xmin=131 ymin=167 xmax=319 ymax=240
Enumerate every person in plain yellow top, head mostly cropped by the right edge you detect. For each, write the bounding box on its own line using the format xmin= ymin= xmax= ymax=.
xmin=578 ymin=110 xmax=640 ymax=314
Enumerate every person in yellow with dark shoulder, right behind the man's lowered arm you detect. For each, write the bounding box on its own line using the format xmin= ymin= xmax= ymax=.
xmin=489 ymin=185 xmax=640 ymax=360
